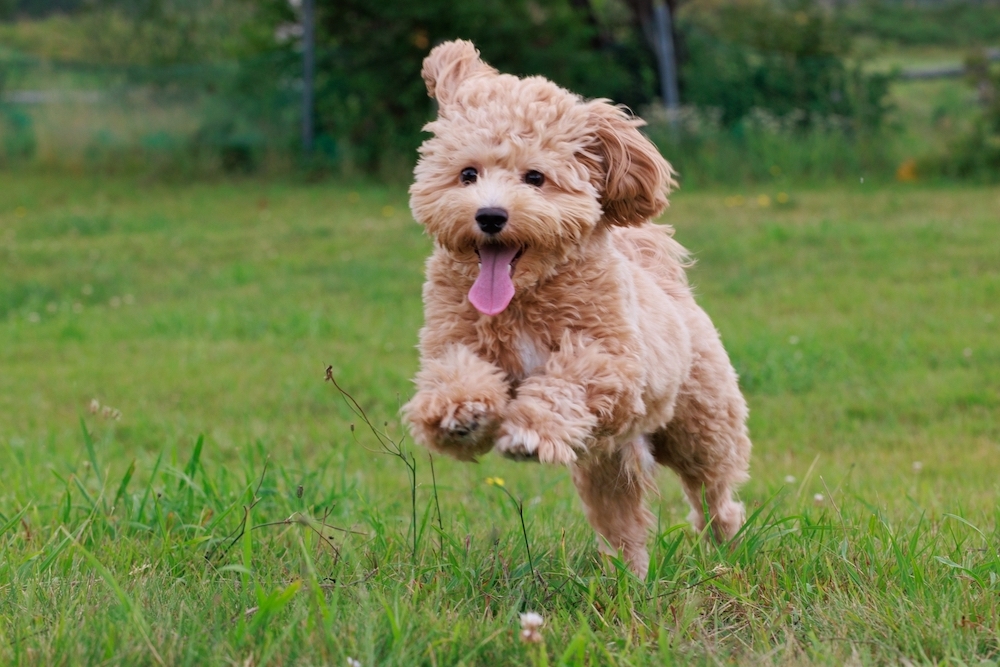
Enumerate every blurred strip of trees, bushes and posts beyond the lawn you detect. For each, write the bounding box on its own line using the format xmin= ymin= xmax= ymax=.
xmin=0 ymin=0 xmax=1000 ymax=186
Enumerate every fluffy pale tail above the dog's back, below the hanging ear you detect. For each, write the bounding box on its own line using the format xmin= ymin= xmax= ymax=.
xmin=612 ymin=223 xmax=694 ymax=298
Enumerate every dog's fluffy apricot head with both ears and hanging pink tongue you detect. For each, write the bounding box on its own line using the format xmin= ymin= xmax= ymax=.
xmin=410 ymin=41 xmax=675 ymax=315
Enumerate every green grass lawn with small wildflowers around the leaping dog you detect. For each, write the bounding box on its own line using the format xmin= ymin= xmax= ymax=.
xmin=0 ymin=172 xmax=1000 ymax=665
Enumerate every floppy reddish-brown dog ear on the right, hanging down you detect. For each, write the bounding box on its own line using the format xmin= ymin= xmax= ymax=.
xmin=581 ymin=100 xmax=677 ymax=226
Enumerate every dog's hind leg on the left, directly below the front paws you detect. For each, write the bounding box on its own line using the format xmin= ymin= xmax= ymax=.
xmin=573 ymin=438 xmax=654 ymax=578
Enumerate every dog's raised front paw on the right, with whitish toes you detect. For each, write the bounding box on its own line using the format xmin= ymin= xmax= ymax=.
xmin=497 ymin=402 xmax=583 ymax=465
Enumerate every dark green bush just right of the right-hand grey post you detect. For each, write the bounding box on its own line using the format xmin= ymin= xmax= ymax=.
xmin=679 ymin=0 xmax=889 ymax=129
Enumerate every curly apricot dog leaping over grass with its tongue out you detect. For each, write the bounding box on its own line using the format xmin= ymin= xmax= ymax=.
xmin=403 ymin=41 xmax=751 ymax=577
